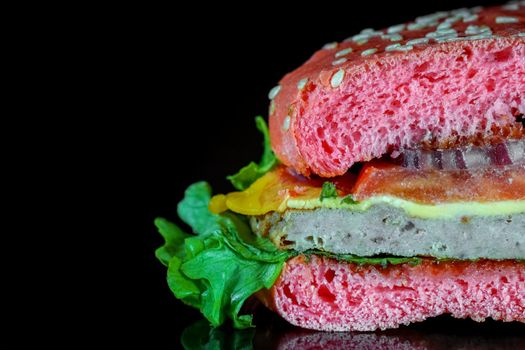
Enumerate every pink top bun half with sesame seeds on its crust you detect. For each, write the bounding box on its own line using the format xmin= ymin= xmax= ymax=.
xmin=269 ymin=1 xmax=525 ymax=177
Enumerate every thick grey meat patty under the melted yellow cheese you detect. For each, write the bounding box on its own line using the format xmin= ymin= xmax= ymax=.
xmin=251 ymin=205 xmax=525 ymax=259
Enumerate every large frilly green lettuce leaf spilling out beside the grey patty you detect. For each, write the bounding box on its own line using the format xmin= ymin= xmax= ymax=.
xmin=155 ymin=182 xmax=291 ymax=329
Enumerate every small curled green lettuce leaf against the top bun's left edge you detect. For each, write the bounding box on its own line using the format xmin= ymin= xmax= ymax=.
xmin=227 ymin=116 xmax=278 ymax=191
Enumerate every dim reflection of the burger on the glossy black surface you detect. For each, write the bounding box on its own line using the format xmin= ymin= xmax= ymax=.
xmin=181 ymin=311 xmax=525 ymax=350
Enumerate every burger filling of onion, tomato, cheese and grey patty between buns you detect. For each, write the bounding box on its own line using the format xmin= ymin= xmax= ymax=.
xmin=210 ymin=140 xmax=525 ymax=260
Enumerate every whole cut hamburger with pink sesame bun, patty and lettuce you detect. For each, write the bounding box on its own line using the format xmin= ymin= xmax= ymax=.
xmin=156 ymin=1 xmax=525 ymax=331
